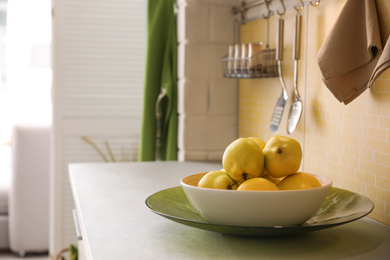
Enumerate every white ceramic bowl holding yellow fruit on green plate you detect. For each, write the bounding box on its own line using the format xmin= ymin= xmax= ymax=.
xmin=181 ymin=173 xmax=333 ymax=227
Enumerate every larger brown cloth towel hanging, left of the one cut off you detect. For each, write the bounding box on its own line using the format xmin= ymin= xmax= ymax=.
xmin=317 ymin=0 xmax=382 ymax=104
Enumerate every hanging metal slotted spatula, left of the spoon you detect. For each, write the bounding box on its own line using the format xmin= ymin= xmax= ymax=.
xmin=269 ymin=16 xmax=288 ymax=133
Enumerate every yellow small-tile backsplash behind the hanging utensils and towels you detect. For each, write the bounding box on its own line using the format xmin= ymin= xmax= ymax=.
xmin=238 ymin=0 xmax=390 ymax=225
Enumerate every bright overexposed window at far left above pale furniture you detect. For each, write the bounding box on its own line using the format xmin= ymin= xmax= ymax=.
xmin=0 ymin=0 xmax=52 ymax=183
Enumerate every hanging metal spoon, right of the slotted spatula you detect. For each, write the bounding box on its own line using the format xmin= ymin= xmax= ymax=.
xmin=287 ymin=11 xmax=303 ymax=134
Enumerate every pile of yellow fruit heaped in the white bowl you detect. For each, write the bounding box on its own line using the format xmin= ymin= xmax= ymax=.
xmin=198 ymin=135 xmax=321 ymax=190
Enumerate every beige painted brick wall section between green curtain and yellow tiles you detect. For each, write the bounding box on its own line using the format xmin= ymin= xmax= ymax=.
xmin=177 ymin=0 xmax=238 ymax=161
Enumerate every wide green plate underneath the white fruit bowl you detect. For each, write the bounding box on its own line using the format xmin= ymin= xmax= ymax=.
xmin=146 ymin=186 xmax=374 ymax=237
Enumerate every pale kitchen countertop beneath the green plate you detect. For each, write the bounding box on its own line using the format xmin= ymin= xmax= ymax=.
xmin=69 ymin=162 xmax=390 ymax=260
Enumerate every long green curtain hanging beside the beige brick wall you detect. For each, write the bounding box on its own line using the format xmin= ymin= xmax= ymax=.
xmin=139 ymin=0 xmax=178 ymax=161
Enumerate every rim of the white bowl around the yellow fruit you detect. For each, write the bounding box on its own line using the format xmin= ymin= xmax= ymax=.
xmin=180 ymin=172 xmax=333 ymax=194
